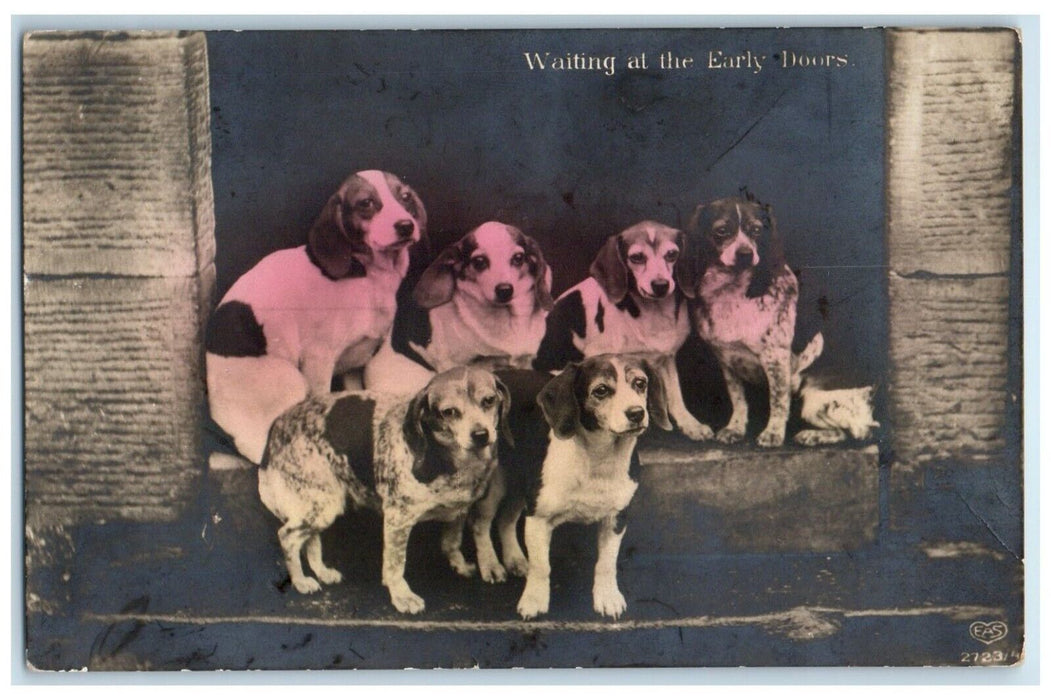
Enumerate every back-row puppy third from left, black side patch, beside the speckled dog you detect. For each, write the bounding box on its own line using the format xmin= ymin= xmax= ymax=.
xmin=533 ymin=221 xmax=714 ymax=440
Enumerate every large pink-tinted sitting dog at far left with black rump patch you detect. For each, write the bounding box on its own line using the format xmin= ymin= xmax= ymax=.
xmin=205 ymin=170 xmax=427 ymax=464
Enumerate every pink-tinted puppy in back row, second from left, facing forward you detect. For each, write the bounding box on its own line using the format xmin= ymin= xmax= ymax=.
xmin=365 ymin=222 xmax=553 ymax=394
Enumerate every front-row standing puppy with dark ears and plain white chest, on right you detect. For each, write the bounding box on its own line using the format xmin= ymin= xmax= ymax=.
xmin=472 ymin=355 xmax=672 ymax=619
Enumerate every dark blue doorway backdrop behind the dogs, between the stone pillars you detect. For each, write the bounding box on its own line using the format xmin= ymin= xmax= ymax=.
xmin=208 ymin=29 xmax=886 ymax=382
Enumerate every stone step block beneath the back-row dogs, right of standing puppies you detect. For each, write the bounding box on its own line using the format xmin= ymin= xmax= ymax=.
xmin=630 ymin=446 xmax=880 ymax=555
